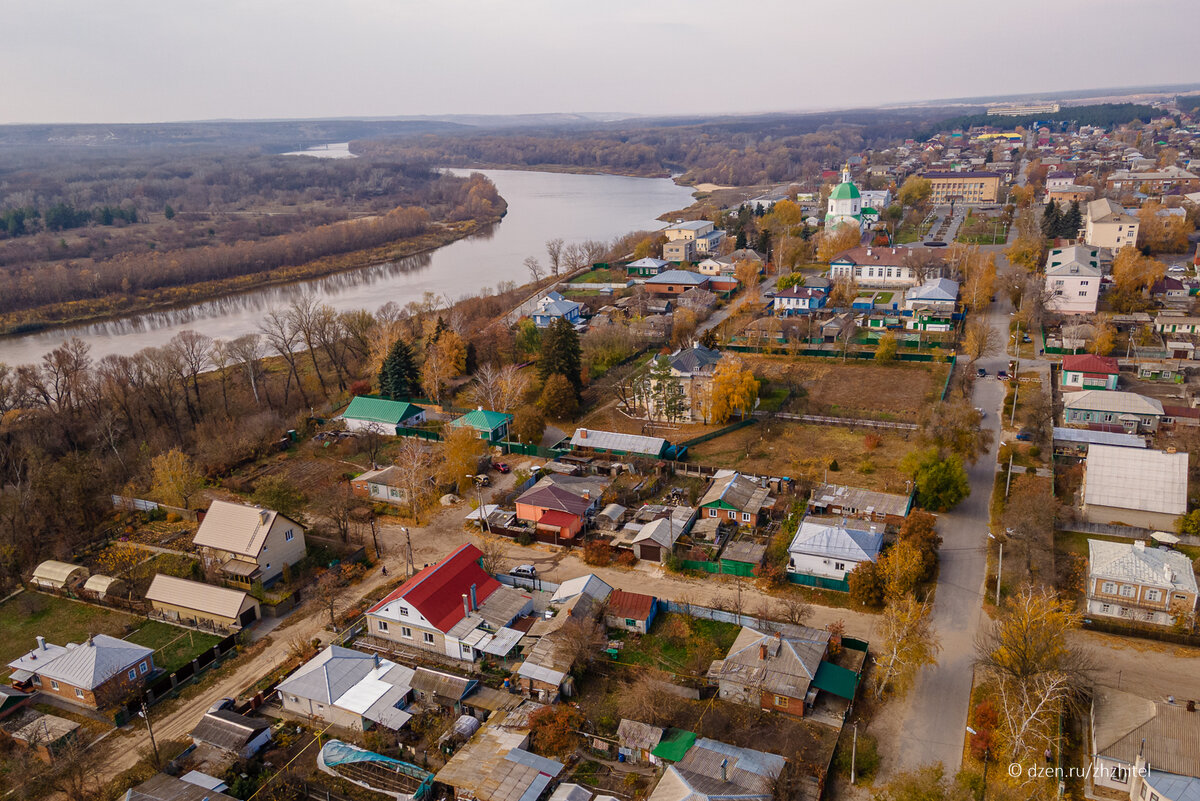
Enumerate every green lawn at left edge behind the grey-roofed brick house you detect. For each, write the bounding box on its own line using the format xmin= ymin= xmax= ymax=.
xmin=0 ymin=590 xmax=138 ymax=676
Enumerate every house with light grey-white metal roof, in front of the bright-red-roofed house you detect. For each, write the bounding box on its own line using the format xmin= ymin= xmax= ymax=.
xmin=277 ymin=645 xmax=415 ymax=731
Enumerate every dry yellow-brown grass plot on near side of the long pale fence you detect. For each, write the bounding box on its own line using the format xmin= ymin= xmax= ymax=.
xmin=688 ymin=420 xmax=917 ymax=493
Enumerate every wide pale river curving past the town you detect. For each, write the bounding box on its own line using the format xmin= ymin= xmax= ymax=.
xmin=0 ymin=170 xmax=692 ymax=365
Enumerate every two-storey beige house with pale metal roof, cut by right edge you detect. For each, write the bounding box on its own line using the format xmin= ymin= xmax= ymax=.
xmin=1087 ymin=540 xmax=1196 ymax=626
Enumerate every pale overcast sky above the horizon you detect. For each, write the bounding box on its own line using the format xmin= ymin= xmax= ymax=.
xmin=0 ymin=0 xmax=1200 ymax=124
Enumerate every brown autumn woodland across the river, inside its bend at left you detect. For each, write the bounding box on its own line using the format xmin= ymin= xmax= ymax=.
xmin=0 ymin=149 xmax=504 ymax=331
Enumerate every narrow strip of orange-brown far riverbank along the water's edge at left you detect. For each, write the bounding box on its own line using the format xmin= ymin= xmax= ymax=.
xmin=0 ymin=204 xmax=508 ymax=339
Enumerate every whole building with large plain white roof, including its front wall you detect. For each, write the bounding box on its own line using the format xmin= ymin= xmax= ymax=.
xmin=1082 ymin=445 xmax=1188 ymax=531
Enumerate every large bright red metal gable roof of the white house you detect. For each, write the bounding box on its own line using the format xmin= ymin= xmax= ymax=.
xmin=367 ymin=543 xmax=500 ymax=632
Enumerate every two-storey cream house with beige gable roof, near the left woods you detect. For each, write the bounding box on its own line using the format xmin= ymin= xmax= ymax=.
xmin=192 ymin=500 xmax=306 ymax=589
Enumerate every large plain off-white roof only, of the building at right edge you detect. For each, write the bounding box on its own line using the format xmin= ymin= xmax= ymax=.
xmin=1084 ymin=445 xmax=1188 ymax=514
